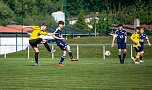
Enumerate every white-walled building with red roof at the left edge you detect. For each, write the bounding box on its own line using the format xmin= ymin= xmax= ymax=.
xmin=0 ymin=25 xmax=32 ymax=55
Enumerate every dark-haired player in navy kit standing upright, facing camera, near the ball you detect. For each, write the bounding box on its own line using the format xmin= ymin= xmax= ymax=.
xmin=111 ymin=24 xmax=127 ymax=64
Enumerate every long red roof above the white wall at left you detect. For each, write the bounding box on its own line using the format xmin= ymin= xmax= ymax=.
xmin=0 ymin=25 xmax=32 ymax=32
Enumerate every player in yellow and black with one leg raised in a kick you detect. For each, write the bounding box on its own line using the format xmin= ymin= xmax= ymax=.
xmin=22 ymin=23 xmax=55 ymax=66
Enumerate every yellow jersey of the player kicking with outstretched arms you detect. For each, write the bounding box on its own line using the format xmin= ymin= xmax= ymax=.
xmin=30 ymin=26 xmax=47 ymax=40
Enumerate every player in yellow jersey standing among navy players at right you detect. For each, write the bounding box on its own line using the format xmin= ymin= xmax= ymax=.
xmin=130 ymin=27 xmax=141 ymax=64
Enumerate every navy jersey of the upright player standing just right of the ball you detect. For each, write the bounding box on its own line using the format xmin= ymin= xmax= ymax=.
xmin=114 ymin=30 xmax=127 ymax=43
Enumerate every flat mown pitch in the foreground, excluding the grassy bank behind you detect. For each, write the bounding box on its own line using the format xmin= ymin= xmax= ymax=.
xmin=0 ymin=58 xmax=152 ymax=90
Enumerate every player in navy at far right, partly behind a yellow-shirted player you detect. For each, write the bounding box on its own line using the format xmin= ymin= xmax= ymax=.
xmin=140 ymin=27 xmax=151 ymax=63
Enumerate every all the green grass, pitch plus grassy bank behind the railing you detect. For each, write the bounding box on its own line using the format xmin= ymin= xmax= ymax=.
xmin=0 ymin=36 xmax=152 ymax=90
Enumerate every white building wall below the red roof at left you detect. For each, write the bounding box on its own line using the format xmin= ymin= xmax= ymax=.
xmin=0 ymin=37 xmax=29 ymax=54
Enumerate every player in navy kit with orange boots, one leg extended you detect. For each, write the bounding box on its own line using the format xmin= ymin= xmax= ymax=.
xmin=53 ymin=21 xmax=78 ymax=66
